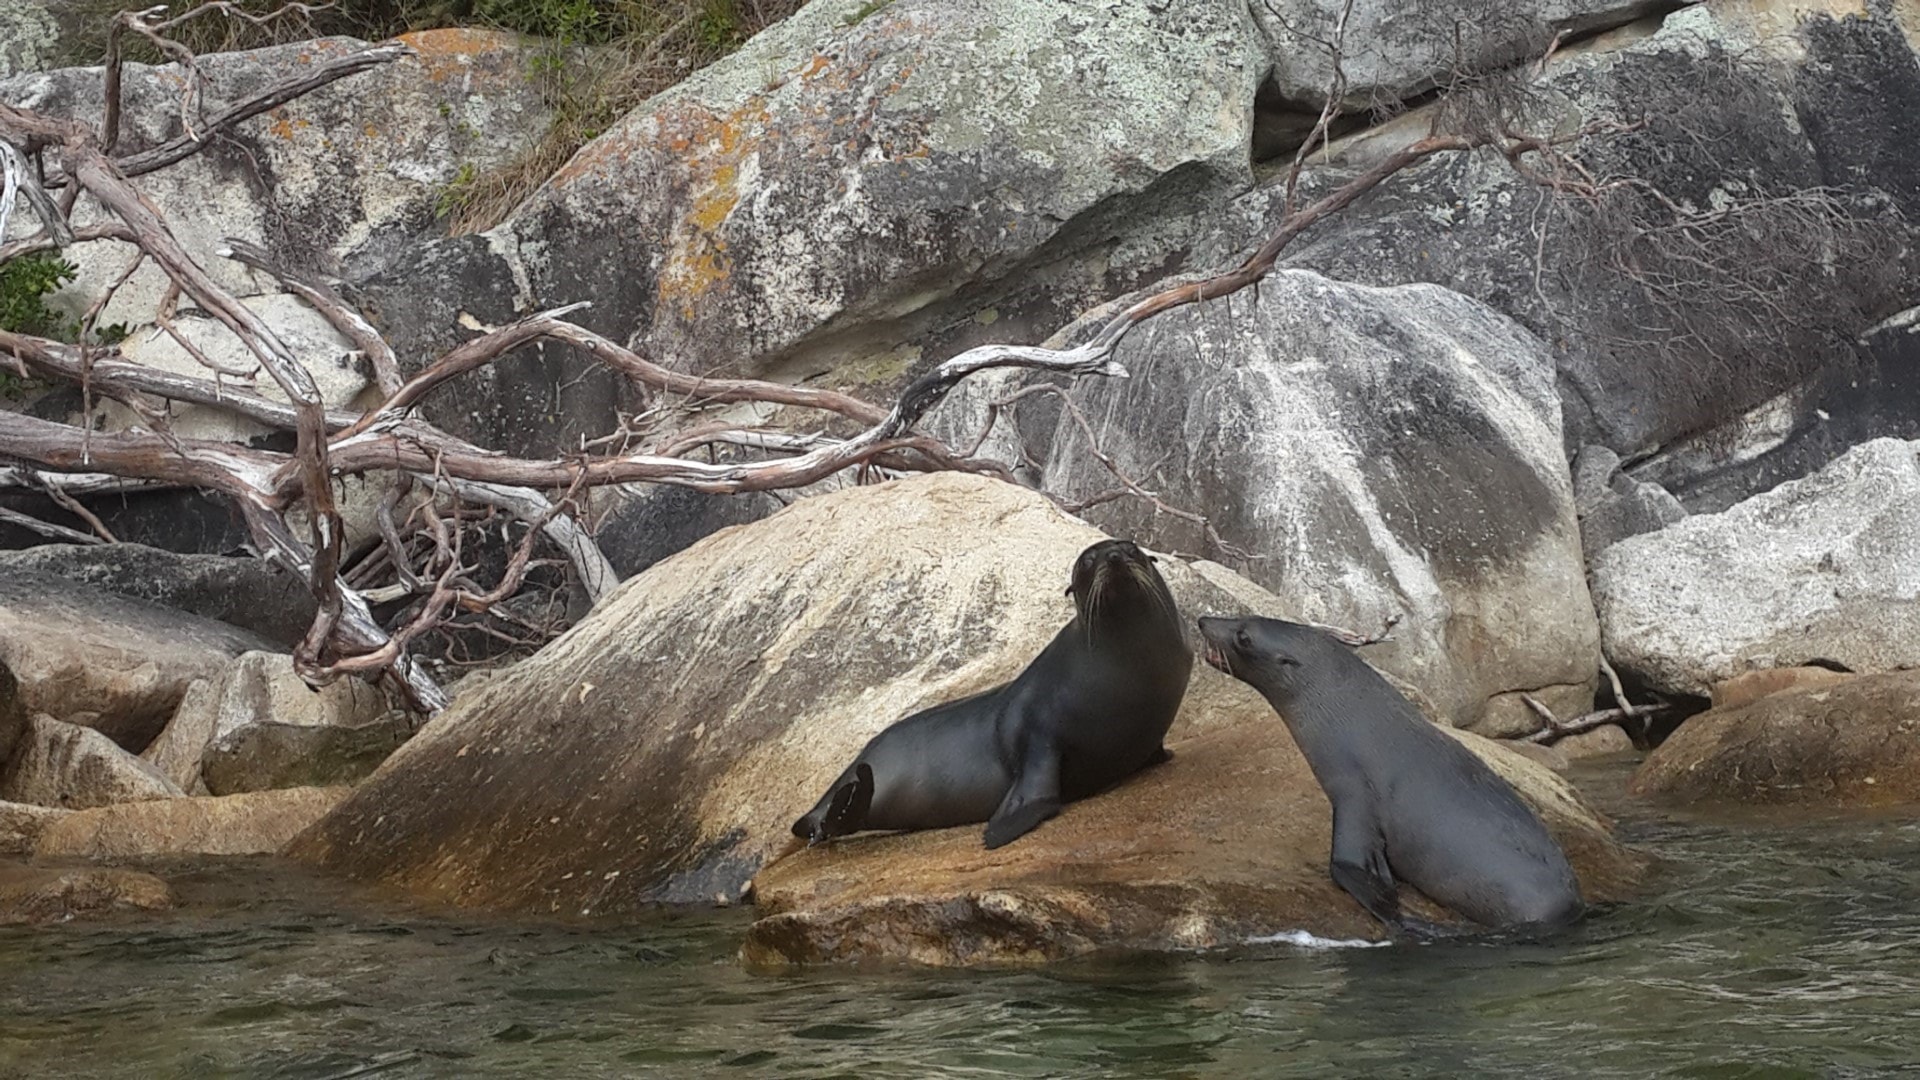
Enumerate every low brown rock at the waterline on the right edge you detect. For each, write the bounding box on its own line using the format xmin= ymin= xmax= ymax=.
xmin=1628 ymin=671 xmax=1920 ymax=807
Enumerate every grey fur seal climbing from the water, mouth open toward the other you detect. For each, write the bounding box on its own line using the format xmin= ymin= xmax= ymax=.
xmin=1200 ymin=619 xmax=1584 ymax=936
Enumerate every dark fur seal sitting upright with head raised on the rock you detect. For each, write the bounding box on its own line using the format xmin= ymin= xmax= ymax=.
xmin=793 ymin=540 xmax=1192 ymax=847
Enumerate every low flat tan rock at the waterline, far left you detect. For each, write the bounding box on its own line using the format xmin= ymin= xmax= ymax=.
xmin=33 ymin=788 xmax=348 ymax=859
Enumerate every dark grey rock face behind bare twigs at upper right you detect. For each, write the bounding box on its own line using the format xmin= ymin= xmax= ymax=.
xmin=1194 ymin=0 xmax=1920 ymax=468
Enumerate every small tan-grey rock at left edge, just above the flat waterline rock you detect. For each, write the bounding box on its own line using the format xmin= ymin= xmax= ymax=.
xmin=0 ymin=717 xmax=186 ymax=809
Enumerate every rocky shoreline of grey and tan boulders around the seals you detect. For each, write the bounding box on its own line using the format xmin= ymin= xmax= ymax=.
xmin=0 ymin=0 xmax=1920 ymax=965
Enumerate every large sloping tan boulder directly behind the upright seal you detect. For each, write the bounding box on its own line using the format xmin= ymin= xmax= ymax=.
xmin=290 ymin=475 xmax=1635 ymax=941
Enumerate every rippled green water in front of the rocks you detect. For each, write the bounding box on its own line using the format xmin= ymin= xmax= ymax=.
xmin=0 ymin=757 xmax=1920 ymax=1080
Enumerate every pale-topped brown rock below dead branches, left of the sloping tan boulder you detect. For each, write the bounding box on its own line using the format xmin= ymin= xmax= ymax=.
xmin=144 ymin=651 xmax=413 ymax=796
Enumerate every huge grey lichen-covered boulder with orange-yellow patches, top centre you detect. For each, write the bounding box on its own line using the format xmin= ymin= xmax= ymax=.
xmin=355 ymin=0 xmax=1267 ymax=450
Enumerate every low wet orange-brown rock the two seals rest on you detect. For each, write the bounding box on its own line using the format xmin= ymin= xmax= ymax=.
xmin=741 ymin=722 xmax=1642 ymax=967
